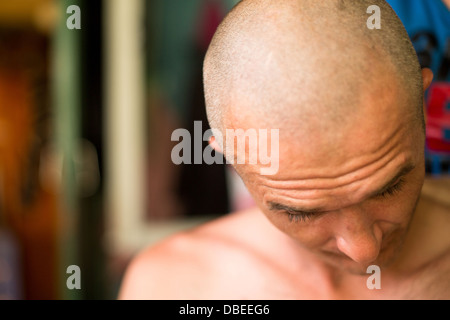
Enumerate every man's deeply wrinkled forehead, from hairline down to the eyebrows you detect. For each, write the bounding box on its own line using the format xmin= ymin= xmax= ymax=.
xmin=236 ymin=90 xmax=423 ymax=210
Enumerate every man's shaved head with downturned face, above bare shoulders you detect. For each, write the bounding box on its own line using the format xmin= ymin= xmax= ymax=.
xmin=200 ymin=0 xmax=432 ymax=274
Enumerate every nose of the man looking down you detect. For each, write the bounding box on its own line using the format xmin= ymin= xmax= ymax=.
xmin=335 ymin=208 xmax=383 ymax=264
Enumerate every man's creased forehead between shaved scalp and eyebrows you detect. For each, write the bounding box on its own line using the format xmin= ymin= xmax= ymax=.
xmin=244 ymin=108 xmax=423 ymax=210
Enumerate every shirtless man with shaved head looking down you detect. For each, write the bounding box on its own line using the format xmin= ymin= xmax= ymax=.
xmin=119 ymin=0 xmax=450 ymax=299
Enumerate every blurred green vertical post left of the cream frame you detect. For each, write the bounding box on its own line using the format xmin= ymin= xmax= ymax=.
xmin=52 ymin=0 xmax=83 ymax=300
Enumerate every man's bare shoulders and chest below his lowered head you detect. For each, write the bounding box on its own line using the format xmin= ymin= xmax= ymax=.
xmin=120 ymin=185 xmax=450 ymax=299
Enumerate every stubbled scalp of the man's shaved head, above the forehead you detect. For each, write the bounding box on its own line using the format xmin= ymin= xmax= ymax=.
xmin=204 ymin=0 xmax=424 ymax=144
